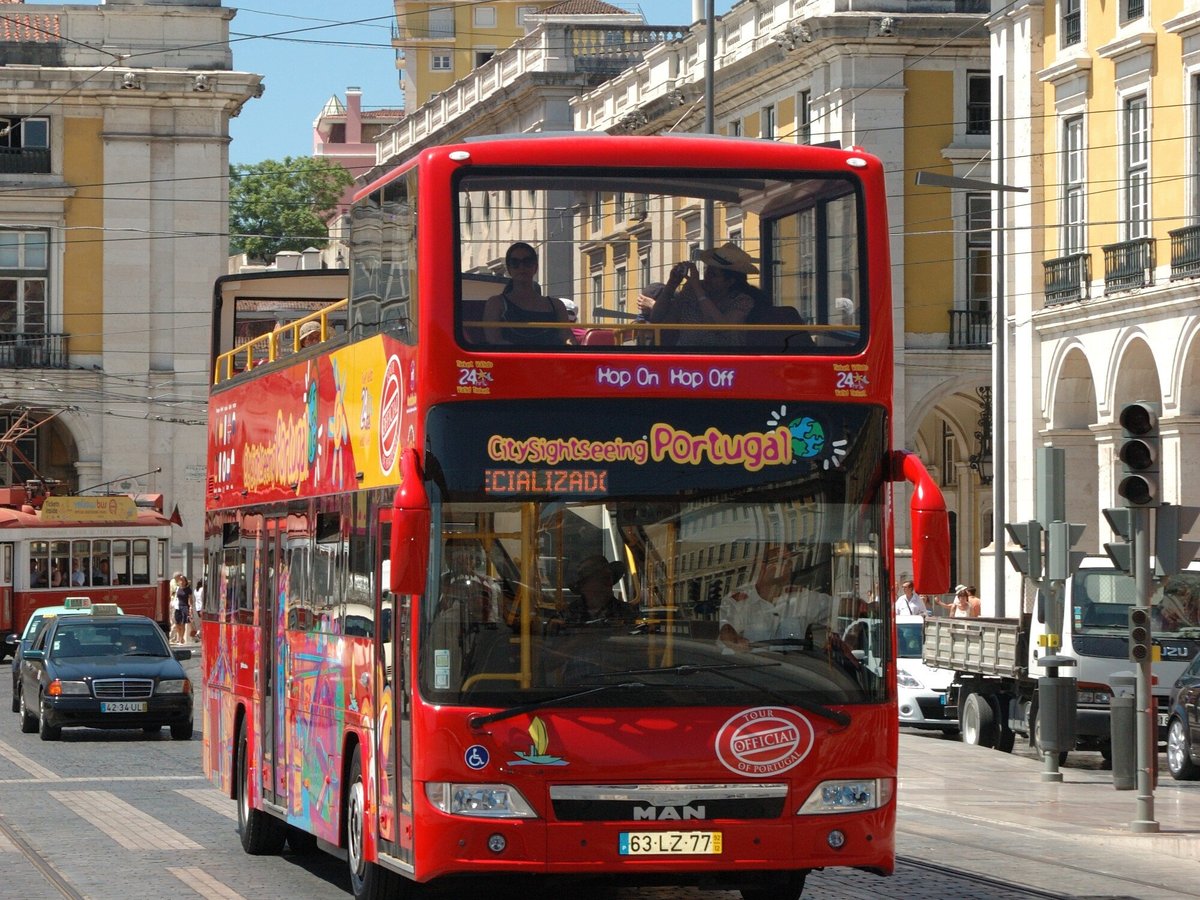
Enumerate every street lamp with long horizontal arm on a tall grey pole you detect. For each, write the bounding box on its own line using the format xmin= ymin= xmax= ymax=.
xmin=917 ymin=165 xmax=1030 ymax=618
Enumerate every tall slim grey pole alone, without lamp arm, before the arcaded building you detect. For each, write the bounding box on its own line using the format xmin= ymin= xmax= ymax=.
xmin=991 ymin=76 xmax=1003 ymax=618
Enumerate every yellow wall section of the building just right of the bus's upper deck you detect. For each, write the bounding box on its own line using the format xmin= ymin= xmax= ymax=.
xmin=902 ymin=70 xmax=962 ymax=334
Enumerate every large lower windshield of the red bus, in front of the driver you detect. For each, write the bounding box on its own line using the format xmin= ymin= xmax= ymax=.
xmin=420 ymin=401 xmax=889 ymax=707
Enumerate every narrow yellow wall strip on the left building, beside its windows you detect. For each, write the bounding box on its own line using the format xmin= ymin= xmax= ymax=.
xmin=56 ymin=116 xmax=106 ymax=354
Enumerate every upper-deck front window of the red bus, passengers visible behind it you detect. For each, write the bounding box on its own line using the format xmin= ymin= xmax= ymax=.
xmin=451 ymin=168 xmax=868 ymax=354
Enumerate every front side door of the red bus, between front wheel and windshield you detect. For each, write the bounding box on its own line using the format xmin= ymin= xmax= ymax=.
xmin=373 ymin=508 xmax=413 ymax=865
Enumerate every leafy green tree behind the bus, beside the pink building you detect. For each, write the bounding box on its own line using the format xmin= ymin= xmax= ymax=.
xmin=229 ymin=156 xmax=354 ymax=260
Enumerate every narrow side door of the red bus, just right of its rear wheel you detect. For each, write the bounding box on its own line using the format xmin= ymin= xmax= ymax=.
xmin=258 ymin=518 xmax=288 ymax=806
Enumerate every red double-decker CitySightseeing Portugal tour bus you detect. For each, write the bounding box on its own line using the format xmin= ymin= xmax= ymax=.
xmin=202 ymin=134 xmax=949 ymax=900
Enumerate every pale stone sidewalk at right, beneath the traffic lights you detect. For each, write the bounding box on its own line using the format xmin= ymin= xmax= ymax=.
xmin=896 ymin=732 xmax=1200 ymax=898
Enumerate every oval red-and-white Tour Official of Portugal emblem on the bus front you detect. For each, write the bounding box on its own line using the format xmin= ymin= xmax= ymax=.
xmin=716 ymin=707 xmax=815 ymax=778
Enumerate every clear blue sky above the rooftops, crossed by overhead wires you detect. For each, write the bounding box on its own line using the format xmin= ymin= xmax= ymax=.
xmin=26 ymin=0 xmax=734 ymax=164
